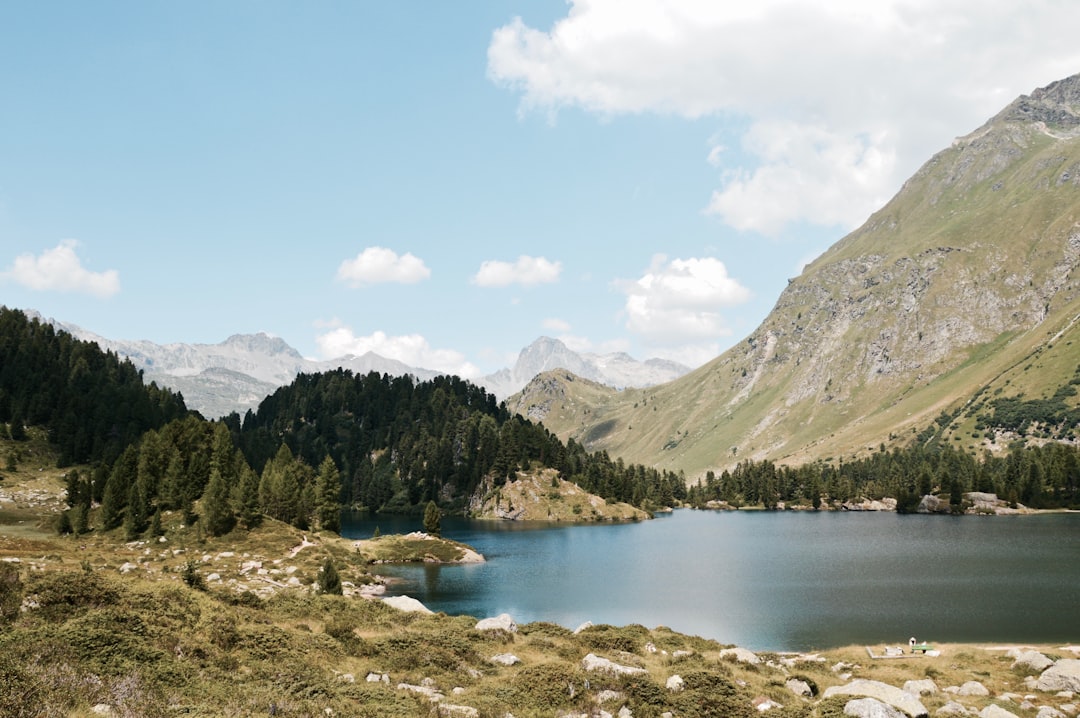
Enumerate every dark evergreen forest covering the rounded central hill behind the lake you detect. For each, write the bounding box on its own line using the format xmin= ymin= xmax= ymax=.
xmin=225 ymin=369 xmax=686 ymax=512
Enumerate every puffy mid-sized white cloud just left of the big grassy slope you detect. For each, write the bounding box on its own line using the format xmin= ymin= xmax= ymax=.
xmin=619 ymin=256 xmax=751 ymax=345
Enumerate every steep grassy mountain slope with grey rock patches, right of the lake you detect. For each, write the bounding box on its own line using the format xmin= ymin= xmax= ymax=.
xmin=510 ymin=76 xmax=1080 ymax=479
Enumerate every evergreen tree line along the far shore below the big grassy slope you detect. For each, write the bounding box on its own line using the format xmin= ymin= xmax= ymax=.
xmin=687 ymin=443 xmax=1080 ymax=512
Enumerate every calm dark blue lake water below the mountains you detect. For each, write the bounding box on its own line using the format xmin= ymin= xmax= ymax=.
xmin=342 ymin=510 xmax=1080 ymax=650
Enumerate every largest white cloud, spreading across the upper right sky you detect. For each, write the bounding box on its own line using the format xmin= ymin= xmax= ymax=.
xmin=488 ymin=0 xmax=1080 ymax=232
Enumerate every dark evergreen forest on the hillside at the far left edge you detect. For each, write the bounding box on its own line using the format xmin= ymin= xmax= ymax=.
xmin=0 ymin=307 xmax=187 ymax=466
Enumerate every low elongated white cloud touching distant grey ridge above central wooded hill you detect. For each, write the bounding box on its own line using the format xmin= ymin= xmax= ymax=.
xmin=315 ymin=326 xmax=480 ymax=379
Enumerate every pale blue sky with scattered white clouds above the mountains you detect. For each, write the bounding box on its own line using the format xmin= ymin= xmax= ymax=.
xmin=0 ymin=0 xmax=1080 ymax=377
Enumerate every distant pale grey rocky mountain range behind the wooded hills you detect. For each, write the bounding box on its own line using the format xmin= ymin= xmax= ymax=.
xmin=35 ymin=311 xmax=690 ymax=418
